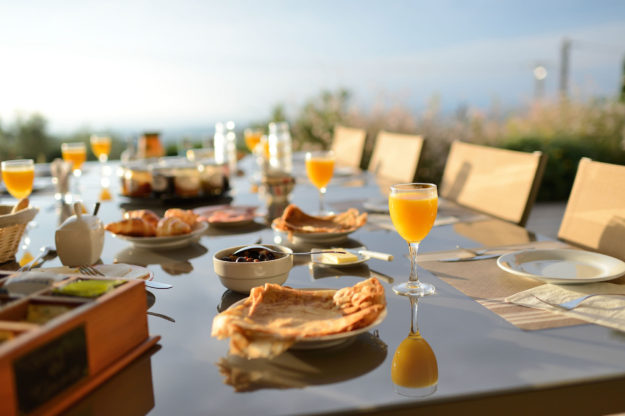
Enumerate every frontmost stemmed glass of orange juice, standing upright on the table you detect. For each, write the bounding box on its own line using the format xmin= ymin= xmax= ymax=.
xmin=388 ymin=183 xmax=438 ymax=296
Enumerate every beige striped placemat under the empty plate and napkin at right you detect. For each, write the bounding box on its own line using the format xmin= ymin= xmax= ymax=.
xmin=419 ymin=241 xmax=604 ymax=330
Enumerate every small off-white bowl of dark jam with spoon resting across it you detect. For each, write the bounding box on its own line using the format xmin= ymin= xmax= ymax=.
xmin=213 ymin=244 xmax=293 ymax=293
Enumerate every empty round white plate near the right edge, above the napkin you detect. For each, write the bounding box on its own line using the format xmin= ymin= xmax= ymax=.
xmin=497 ymin=249 xmax=625 ymax=284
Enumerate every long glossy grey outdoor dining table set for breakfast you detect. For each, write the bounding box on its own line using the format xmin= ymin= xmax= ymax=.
xmin=12 ymin=161 xmax=625 ymax=415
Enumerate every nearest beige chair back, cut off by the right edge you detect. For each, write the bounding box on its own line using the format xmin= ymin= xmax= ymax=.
xmin=558 ymin=158 xmax=625 ymax=260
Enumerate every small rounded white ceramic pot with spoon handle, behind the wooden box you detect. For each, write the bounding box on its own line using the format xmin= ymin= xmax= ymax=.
xmin=54 ymin=202 xmax=104 ymax=267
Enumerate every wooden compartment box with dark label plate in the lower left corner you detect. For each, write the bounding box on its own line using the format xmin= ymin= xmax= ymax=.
xmin=0 ymin=277 xmax=159 ymax=415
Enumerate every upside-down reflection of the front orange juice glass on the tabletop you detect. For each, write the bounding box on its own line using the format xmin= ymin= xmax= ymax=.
xmin=391 ymin=296 xmax=438 ymax=397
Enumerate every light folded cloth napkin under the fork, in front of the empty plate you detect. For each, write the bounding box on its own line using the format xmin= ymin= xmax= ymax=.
xmin=505 ymin=283 xmax=625 ymax=331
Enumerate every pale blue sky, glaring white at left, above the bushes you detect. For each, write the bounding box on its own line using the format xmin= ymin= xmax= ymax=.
xmin=0 ymin=0 xmax=625 ymax=130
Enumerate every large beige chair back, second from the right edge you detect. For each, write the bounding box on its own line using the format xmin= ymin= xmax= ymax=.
xmin=439 ymin=141 xmax=547 ymax=225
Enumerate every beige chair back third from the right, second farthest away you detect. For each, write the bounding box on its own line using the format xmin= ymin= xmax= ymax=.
xmin=369 ymin=131 xmax=423 ymax=183
